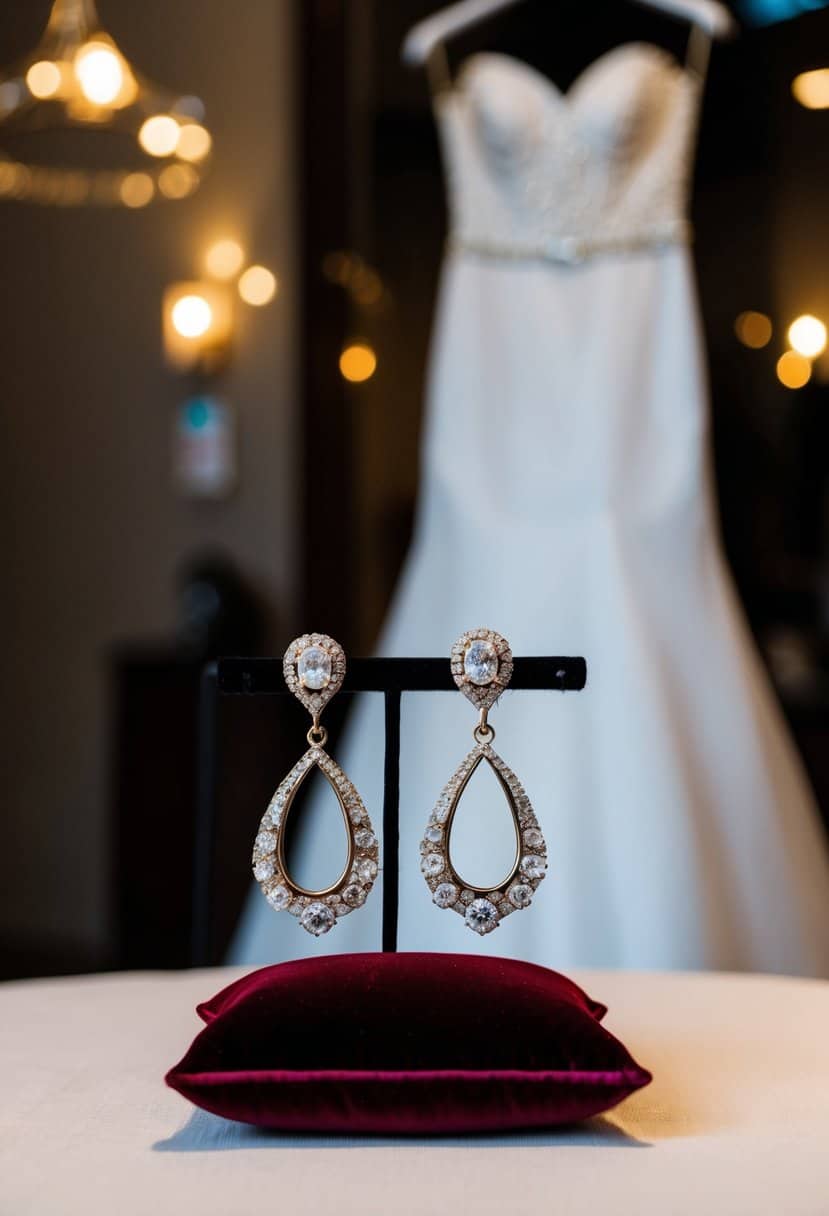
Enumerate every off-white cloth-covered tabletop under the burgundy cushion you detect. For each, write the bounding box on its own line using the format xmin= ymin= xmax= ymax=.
xmin=0 ymin=968 xmax=829 ymax=1216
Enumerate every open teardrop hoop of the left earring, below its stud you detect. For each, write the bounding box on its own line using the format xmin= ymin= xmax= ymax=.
xmin=252 ymin=744 xmax=379 ymax=938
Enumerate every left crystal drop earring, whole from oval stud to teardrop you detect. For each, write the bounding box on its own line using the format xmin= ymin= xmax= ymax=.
xmin=253 ymin=634 xmax=378 ymax=938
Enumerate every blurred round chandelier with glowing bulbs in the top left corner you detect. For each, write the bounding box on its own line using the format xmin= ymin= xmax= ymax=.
xmin=0 ymin=0 xmax=212 ymax=207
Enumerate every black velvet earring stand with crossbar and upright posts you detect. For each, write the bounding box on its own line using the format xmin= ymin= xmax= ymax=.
xmin=192 ymin=658 xmax=587 ymax=967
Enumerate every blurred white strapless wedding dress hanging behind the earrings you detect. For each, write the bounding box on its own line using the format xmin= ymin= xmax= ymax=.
xmin=235 ymin=44 xmax=829 ymax=975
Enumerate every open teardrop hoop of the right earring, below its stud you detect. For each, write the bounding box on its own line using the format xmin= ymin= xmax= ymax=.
xmin=421 ymin=743 xmax=547 ymax=936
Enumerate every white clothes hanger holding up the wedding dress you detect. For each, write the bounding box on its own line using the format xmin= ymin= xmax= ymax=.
xmin=402 ymin=0 xmax=737 ymax=91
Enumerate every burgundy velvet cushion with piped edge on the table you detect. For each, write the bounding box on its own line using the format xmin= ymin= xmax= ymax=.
xmin=167 ymin=953 xmax=650 ymax=1135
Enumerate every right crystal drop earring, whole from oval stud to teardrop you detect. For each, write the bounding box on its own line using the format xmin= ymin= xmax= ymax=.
xmin=421 ymin=629 xmax=547 ymax=935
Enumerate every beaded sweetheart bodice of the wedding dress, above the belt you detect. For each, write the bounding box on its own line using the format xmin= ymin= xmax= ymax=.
xmin=438 ymin=43 xmax=700 ymax=261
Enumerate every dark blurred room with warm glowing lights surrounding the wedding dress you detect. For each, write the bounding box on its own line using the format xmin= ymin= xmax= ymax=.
xmin=0 ymin=0 xmax=829 ymax=978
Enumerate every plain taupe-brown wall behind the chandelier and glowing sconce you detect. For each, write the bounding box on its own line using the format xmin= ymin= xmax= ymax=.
xmin=0 ymin=0 xmax=297 ymax=967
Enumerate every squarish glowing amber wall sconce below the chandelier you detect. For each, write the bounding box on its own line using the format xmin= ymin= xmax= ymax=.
xmin=162 ymin=282 xmax=233 ymax=373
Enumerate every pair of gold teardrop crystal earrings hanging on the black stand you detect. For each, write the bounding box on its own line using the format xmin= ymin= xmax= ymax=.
xmin=253 ymin=629 xmax=547 ymax=938
